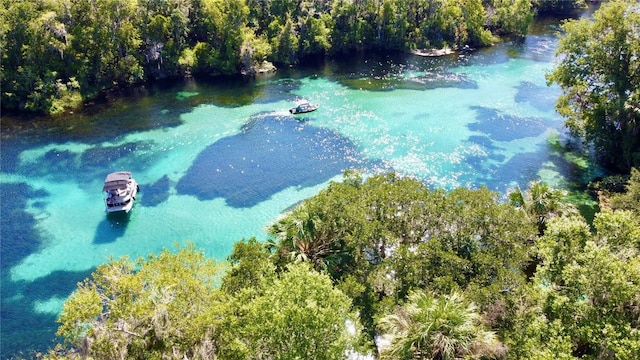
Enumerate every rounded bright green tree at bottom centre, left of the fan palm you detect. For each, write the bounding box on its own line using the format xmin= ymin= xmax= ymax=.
xmin=236 ymin=264 xmax=360 ymax=360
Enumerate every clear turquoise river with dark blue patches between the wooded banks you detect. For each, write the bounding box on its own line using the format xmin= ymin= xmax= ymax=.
xmin=0 ymin=19 xmax=592 ymax=358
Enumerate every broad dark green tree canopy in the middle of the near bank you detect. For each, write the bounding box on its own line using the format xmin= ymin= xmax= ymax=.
xmin=271 ymin=173 xmax=535 ymax=338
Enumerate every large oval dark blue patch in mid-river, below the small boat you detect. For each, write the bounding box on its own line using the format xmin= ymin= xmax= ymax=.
xmin=176 ymin=113 xmax=376 ymax=208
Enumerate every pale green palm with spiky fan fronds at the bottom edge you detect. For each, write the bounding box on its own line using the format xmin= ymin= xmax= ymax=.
xmin=378 ymin=291 xmax=503 ymax=360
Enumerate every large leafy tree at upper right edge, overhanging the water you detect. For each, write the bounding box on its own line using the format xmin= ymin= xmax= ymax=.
xmin=547 ymin=0 xmax=640 ymax=170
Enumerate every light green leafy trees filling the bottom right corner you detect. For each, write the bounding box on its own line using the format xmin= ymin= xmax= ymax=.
xmin=511 ymin=211 xmax=640 ymax=359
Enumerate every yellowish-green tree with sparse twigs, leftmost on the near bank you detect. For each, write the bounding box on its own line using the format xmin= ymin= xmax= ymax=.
xmin=58 ymin=246 xmax=228 ymax=359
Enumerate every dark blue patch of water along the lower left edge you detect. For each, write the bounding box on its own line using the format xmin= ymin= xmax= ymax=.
xmin=0 ymin=183 xmax=91 ymax=359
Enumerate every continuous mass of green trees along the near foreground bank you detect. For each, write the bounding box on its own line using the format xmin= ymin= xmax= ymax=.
xmin=49 ymin=170 xmax=640 ymax=359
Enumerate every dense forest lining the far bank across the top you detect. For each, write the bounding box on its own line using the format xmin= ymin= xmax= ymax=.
xmin=0 ymin=0 xmax=584 ymax=114
